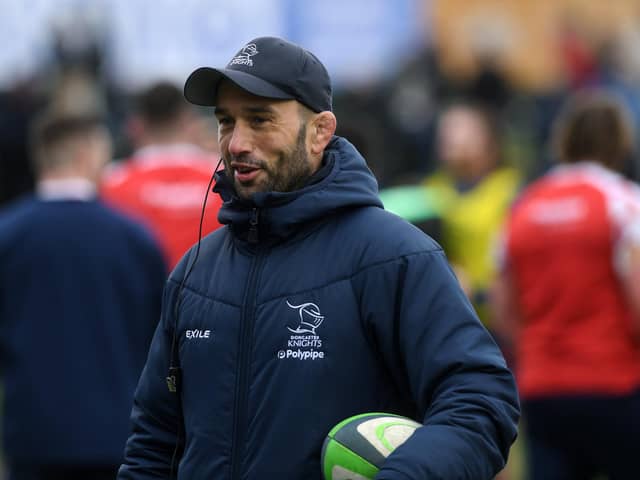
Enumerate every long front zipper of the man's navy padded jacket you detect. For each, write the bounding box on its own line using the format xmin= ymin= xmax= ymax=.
xmin=231 ymin=208 xmax=263 ymax=480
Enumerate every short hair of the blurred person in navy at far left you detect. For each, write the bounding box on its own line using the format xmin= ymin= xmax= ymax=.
xmin=31 ymin=112 xmax=105 ymax=171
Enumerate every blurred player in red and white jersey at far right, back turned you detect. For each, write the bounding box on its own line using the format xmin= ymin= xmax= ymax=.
xmin=493 ymin=91 xmax=640 ymax=480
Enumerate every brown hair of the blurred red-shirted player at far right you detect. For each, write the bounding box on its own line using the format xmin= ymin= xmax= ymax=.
xmin=551 ymin=90 xmax=634 ymax=170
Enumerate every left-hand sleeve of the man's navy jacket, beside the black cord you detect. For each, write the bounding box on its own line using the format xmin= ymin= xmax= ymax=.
xmin=117 ymin=280 xmax=182 ymax=480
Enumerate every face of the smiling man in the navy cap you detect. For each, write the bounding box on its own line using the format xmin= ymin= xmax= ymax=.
xmin=216 ymin=82 xmax=315 ymax=199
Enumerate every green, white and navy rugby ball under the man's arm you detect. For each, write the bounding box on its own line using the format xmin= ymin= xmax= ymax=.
xmin=322 ymin=413 xmax=422 ymax=480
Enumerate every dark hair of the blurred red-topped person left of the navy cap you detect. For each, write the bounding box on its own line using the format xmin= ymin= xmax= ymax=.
xmin=135 ymin=82 xmax=190 ymax=128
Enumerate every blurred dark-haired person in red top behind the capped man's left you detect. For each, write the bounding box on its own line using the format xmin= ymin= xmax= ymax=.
xmin=102 ymin=83 xmax=221 ymax=268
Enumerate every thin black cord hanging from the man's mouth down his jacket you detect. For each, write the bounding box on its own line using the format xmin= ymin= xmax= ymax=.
xmin=167 ymin=156 xmax=222 ymax=479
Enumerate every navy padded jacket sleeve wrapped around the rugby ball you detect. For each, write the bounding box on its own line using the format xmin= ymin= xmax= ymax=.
xmin=354 ymin=250 xmax=520 ymax=480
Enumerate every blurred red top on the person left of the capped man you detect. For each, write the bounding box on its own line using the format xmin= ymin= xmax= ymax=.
xmin=101 ymin=146 xmax=222 ymax=269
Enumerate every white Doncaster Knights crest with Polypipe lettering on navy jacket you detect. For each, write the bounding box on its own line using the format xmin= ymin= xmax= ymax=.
xmin=278 ymin=300 xmax=324 ymax=360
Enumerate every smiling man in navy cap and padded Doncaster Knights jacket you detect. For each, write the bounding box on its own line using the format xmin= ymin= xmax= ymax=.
xmin=118 ymin=37 xmax=518 ymax=480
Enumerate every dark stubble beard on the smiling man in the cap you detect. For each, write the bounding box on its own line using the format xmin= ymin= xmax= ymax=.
xmin=229 ymin=124 xmax=314 ymax=199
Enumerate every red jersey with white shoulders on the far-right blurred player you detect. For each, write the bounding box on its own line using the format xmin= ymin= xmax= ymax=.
xmin=504 ymin=162 xmax=640 ymax=398
